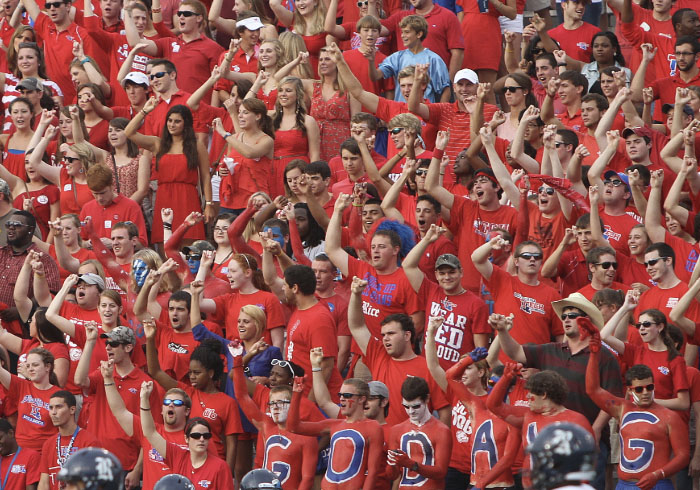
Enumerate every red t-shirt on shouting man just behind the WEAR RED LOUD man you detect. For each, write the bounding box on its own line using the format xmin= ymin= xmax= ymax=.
xmin=447 ymin=196 xmax=518 ymax=293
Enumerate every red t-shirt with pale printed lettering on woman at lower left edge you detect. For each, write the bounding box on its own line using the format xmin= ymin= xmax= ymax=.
xmin=7 ymin=374 xmax=60 ymax=452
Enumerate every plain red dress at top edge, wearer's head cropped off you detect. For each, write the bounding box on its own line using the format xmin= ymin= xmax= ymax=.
xmin=457 ymin=0 xmax=502 ymax=71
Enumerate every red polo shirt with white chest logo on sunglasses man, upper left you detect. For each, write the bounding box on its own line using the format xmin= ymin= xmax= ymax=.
xmin=155 ymin=34 xmax=224 ymax=103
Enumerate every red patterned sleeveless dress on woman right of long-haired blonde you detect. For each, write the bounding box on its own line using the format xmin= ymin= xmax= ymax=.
xmin=311 ymin=83 xmax=350 ymax=162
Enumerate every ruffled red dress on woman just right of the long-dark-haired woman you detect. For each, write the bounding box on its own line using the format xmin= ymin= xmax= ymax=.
xmin=219 ymin=142 xmax=272 ymax=209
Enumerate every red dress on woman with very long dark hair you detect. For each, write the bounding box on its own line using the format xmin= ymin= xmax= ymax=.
xmin=151 ymin=153 xmax=204 ymax=243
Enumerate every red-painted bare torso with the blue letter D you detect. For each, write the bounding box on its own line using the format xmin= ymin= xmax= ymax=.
xmin=389 ymin=417 xmax=452 ymax=490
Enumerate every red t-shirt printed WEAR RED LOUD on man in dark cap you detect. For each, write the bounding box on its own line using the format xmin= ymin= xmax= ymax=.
xmin=418 ymin=280 xmax=492 ymax=370
